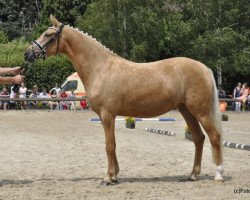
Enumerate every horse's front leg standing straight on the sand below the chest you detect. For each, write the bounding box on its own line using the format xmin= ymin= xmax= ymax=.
xmin=100 ymin=112 xmax=119 ymax=186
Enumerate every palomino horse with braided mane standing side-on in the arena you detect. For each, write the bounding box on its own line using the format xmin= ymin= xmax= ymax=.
xmin=25 ymin=15 xmax=223 ymax=185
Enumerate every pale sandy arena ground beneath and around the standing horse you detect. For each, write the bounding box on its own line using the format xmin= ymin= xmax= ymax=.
xmin=0 ymin=110 xmax=250 ymax=200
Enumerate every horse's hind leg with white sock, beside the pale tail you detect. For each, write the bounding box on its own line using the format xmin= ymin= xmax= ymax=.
xmin=196 ymin=115 xmax=223 ymax=181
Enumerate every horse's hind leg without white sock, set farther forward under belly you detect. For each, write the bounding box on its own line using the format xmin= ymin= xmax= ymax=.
xmin=178 ymin=104 xmax=205 ymax=180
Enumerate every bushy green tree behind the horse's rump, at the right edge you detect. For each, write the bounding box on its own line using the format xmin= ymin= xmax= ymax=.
xmin=164 ymin=0 xmax=250 ymax=90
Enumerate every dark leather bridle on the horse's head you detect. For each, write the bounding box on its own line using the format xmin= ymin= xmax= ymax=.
xmin=32 ymin=24 xmax=64 ymax=59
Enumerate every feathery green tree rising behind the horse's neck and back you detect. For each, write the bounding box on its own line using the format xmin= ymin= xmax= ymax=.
xmin=77 ymin=0 xmax=166 ymax=61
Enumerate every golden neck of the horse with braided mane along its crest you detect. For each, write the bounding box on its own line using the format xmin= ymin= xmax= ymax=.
xmin=61 ymin=27 xmax=114 ymax=89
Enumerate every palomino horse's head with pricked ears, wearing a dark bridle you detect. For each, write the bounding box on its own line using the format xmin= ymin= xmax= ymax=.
xmin=24 ymin=15 xmax=64 ymax=62
